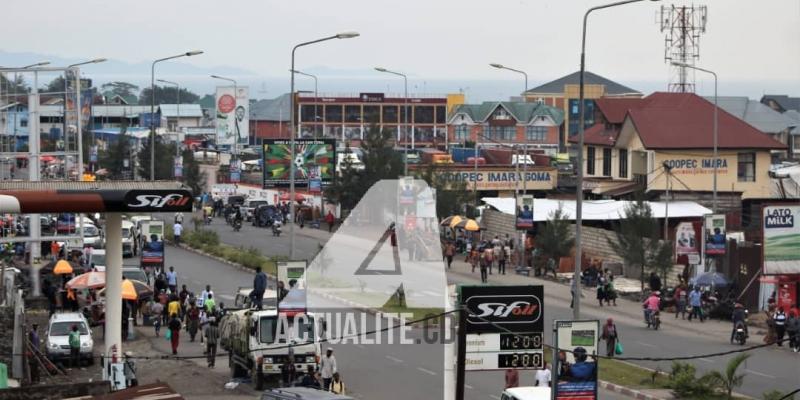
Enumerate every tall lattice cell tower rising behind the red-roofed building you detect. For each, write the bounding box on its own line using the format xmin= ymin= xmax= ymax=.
xmin=659 ymin=5 xmax=708 ymax=92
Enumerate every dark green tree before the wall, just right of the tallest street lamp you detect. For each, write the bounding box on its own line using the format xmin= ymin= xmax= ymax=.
xmin=606 ymin=195 xmax=672 ymax=291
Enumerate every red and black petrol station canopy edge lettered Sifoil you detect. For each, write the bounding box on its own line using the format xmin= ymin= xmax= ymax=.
xmin=0 ymin=181 xmax=193 ymax=214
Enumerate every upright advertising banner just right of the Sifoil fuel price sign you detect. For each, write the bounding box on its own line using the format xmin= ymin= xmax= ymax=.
xmin=553 ymin=320 xmax=600 ymax=400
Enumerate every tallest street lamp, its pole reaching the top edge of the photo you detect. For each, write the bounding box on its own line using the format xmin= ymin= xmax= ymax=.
xmin=572 ymin=0 xmax=658 ymax=320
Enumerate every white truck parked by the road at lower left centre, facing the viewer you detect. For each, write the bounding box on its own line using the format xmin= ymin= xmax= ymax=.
xmin=220 ymin=308 xmax=324 ymax=390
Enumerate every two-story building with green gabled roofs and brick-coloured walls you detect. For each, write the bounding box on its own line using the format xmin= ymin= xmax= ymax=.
xmin=447 ymin=101 xmax=564 ymax=154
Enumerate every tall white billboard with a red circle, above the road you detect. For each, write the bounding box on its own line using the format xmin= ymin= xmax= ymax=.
xmin=215 ymin=86 xmax=250 ymax=146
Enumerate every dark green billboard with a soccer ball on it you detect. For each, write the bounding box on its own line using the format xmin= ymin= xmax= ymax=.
xmin=261 ymin=139 xmax=336 ymax=188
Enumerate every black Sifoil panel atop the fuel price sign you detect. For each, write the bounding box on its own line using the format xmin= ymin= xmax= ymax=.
xmin=461 ymin=286 xmax=544 ymax=334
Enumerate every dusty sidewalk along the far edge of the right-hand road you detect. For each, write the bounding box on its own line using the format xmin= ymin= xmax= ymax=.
xmin=447 ymin=255 xmax=744 ymax=343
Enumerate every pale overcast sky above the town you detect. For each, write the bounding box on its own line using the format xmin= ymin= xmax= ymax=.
xmin=0 ymin=0 xmax=800 ymax=100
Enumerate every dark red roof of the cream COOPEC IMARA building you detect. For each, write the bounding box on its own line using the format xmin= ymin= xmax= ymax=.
xmin=628 ymin=92 xmax=786 ymax=149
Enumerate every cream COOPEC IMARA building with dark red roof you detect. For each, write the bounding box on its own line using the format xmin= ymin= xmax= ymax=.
xmin=573 ymin=93 xmax=786 ymax=227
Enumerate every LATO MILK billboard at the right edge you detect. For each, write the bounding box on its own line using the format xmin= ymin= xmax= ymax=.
xmin=762 ymin=205 xmax=800 ymax=275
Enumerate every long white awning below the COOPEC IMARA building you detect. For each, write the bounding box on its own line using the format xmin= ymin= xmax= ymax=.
xmin=481 ymin=197 xmax=711 ymax=222
